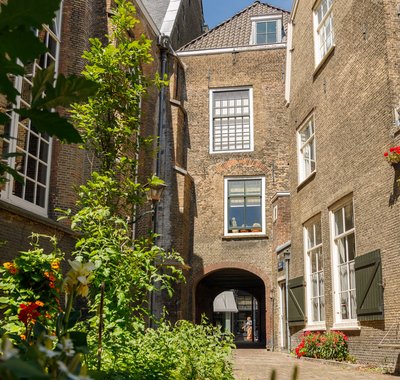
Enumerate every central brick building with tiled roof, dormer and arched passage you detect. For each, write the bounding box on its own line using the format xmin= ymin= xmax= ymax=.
xmin=178 ymin=1 xmax=289 ymax=346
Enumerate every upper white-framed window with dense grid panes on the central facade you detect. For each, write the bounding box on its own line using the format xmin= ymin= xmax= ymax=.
xmin=210 ymin=88 xmax=253 ymax=153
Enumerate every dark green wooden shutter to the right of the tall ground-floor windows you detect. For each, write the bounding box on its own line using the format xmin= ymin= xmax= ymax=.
xmin=354 ymin=250 xmax=383 ymax=321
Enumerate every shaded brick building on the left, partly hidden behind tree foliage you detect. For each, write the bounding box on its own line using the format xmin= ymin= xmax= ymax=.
xmin=0 ymin=0 xmax=203 ymax=326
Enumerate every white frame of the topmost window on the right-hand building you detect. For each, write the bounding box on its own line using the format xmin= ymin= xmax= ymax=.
xmin=313 ymin=0 xmax=335 ymax=67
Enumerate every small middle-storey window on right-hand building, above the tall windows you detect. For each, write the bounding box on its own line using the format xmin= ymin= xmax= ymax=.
xmin=297 ymin=116 xmax=315 ymax=182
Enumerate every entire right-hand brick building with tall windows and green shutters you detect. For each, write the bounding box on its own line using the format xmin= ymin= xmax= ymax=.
xmin=286 ymin=0 xmax=400 ymax=370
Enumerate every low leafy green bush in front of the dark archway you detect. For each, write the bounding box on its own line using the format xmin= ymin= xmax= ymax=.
xmin=91 ymin=321 xmax=234 ymax=380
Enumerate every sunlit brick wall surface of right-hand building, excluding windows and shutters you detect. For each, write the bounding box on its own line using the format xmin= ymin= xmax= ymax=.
xmin=289 ymin=0 xmax=400 ymax=367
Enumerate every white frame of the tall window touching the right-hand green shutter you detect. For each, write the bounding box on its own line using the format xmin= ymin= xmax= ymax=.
xmin=329 ymin=198 xmax=360 ymax=329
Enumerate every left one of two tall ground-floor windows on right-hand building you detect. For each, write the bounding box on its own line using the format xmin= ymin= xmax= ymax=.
xmin=304 ymin=220 xmax=325 ymax=325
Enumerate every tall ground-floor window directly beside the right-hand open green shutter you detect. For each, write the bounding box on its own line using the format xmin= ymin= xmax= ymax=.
xmin=332 ymin=202 xmax=356 ymax=322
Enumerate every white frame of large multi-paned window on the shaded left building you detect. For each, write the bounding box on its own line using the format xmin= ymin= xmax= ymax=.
xmin=0 ymin=8 xmax=63 ymax=217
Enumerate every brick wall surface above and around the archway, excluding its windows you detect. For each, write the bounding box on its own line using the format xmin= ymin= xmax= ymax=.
xmin=182 ymin=49 xmax=288 ymax=344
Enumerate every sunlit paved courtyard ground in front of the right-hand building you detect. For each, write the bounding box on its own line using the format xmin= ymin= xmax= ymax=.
xmin=234 ymin=348 xmax=396 ymax=380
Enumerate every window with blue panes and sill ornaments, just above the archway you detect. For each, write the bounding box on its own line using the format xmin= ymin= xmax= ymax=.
xmin=225 ymin=177 xmax=265 ymax=235
